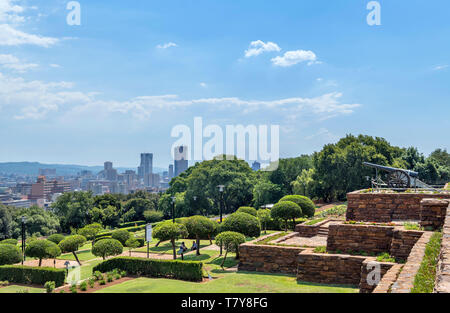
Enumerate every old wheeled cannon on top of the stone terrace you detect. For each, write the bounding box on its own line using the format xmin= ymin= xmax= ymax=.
xmin=363 ymin=162 xmax=420 ymax=190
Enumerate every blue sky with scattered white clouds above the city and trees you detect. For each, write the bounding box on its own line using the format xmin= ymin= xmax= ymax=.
xmin=0 ymin=0 xmax=450 ymax=167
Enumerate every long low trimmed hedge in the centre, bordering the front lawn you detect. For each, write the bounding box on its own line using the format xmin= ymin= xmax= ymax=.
xmin=92 ymin=257 xmax=203 ymax=282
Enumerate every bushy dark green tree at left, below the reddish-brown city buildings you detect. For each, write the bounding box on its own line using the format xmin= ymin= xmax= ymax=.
xmin=52 ymin=191 xmax=94 ymax=232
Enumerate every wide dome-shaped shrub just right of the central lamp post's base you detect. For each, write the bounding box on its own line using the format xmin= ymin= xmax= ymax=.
xmin=219 ymin=213 xmax=261 ymax=237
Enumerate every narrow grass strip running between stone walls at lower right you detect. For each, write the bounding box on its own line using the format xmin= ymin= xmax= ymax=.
xmin=411 ymin=233 xmax=442 ymax=293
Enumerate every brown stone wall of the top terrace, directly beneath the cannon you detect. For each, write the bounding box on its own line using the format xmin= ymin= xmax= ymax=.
xmin=346 ymin=191 xmax=450 ymax=223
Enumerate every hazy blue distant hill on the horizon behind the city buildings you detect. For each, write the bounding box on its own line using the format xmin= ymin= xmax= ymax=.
xmin=0 ymin=162 xmax=166 ymax=176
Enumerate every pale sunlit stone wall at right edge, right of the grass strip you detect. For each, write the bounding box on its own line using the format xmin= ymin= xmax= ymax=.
xmin=434 ymin=201 xmax=450 ymax=293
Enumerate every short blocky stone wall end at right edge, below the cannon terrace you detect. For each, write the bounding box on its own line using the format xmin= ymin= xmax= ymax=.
xmin=420 ymin=198 xmax=450 ymax=230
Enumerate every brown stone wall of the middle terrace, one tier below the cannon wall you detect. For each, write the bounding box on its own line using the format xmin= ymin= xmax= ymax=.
xmin=327 ymin=224 xmax=394 ymax=254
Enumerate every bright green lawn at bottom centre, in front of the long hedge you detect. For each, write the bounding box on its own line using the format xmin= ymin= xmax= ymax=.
xmin=97 ymin=272 xmax=358 ymax=294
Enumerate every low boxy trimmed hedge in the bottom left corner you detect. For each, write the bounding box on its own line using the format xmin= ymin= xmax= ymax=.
xmin=0 ymin=265 xmax=66 ymax=287
